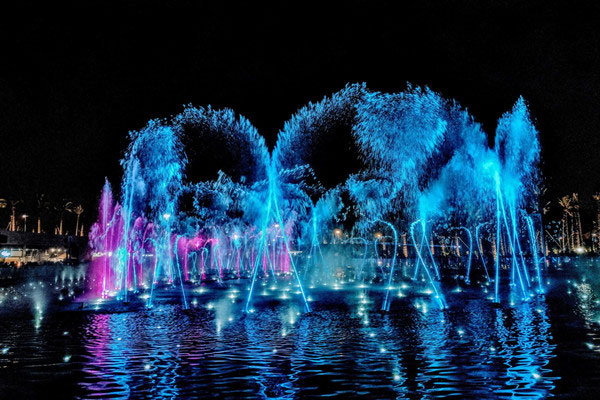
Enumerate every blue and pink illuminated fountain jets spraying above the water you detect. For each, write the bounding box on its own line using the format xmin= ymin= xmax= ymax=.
xmin=90 ymin=85 xmax=544 ymax=312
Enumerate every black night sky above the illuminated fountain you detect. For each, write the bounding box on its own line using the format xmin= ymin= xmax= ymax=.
xmin=0 ymin=0 xmax=600 ymax=222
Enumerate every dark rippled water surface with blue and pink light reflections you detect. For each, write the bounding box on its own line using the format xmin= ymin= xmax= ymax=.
xmin=0 ymin=260 xmax=600 ymax=399
